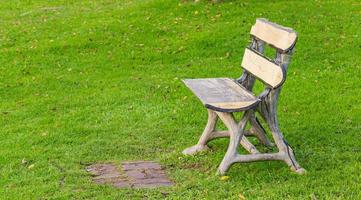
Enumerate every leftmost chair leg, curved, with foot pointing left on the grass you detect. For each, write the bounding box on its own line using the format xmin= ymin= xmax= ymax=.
xmin=182 ymin=109 xmax=218 ymax=155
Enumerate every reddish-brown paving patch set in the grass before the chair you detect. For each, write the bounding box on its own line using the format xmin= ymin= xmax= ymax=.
xmin=86 ymin=161 xmax=173 ymax=188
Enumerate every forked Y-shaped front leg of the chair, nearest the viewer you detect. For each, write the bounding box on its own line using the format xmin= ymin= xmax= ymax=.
xmin=217 ymin=111 xmax=252 ymax=174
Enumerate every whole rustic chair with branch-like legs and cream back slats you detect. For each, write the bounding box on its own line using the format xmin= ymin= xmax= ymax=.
xmin=183 ymin=19 xmax=305 ymax=174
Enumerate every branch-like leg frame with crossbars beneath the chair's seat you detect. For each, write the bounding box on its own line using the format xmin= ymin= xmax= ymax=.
xmin=183 ymin=109 xmax=305 ymax=175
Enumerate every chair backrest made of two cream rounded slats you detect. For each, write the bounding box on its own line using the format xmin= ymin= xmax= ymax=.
xmin=242 ymin=19 xmax=297 ymax=88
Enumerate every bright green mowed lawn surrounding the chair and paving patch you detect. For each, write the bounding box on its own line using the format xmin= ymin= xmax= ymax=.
xmin=0 ymin=0 xmax=361 ymax=199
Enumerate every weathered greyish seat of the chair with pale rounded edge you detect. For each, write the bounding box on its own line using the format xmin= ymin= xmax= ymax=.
xmin=183 ymin=78 xmax=260 ymax=112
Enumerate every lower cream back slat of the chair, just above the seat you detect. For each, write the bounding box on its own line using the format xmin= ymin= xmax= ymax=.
xmin=242 ymin=48 xmax=286 ymax=88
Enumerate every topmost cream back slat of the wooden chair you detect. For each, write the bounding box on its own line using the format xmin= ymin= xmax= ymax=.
xmin=251 ymin=18 xmax=297 ymax=51
